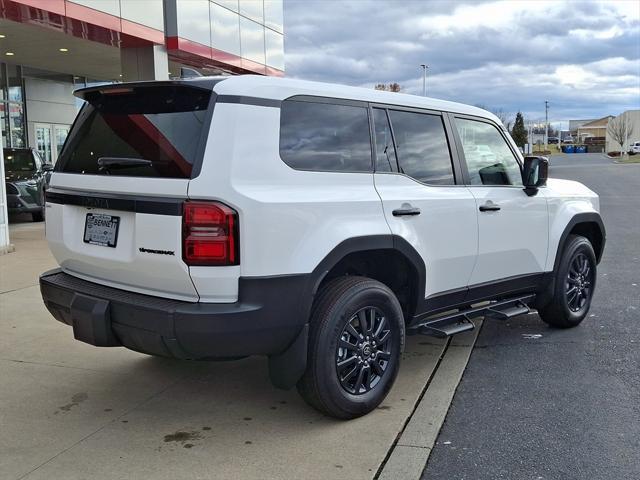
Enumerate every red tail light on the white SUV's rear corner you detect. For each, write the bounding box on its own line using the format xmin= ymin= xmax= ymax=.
xmin=182 ymin=202 xmax=239 ymax=266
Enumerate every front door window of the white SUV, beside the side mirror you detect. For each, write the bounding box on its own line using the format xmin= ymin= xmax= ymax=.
xmin=456 ymin=118 xmax=522 ymax=185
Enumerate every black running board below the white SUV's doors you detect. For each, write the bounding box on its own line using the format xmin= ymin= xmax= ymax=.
xmin=407 ymin=295 xmax=535 ymax=338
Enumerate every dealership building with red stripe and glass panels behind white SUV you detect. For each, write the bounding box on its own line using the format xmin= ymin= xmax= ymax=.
xmin=0 ymin=0 xmax=284 ymax=251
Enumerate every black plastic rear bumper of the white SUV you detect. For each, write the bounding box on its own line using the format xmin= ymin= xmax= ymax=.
xmin=40 ymin=269 xmax=310 ymax=363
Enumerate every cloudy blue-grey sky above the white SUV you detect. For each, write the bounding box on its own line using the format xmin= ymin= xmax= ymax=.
xmin=284 ymin=0 xmax=640 ymax=128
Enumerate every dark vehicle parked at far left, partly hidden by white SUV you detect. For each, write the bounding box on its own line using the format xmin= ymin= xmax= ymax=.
xmin=4 ymin=148 xmax=53 ymax=222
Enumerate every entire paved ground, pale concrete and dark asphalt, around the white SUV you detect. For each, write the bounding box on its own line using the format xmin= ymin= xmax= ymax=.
xmin=0 ymin=155 xmax=640 ymax=480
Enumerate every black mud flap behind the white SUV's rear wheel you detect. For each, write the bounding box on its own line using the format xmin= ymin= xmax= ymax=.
xmin=269 ymin=323 xmax=309 ymax=390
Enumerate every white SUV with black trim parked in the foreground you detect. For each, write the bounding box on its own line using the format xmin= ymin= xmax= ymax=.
xmin=40 ymin=76 xmax=605 ymax=418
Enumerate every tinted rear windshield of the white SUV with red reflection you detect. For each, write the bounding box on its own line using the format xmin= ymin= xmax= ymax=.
xmin=58 ymin=86 xmax=211 ymax=178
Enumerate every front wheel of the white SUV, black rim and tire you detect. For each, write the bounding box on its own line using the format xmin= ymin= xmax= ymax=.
xmin=538 ymin=235 xmax=597 ymax=328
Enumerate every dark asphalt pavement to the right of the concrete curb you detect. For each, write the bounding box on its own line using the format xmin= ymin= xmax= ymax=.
xmin=423 ymin=154 xmax=640 ymax=480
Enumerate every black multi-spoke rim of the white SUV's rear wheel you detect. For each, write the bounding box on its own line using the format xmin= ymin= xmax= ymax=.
xmin=336 ymin=307 xmax=392 ymax=395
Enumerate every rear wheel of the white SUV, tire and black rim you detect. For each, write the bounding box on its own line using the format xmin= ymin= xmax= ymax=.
xmin=297 ymin=276 xmax=404 ymax=419
